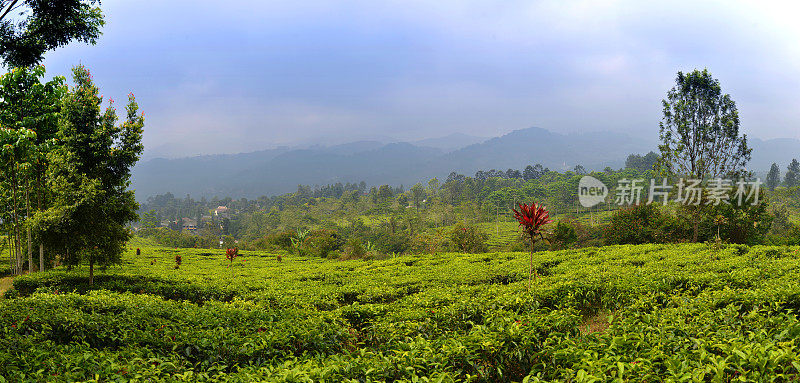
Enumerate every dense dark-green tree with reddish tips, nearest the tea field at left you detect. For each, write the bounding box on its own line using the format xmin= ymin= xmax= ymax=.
xmin=36 ymin=66 xmax=144 ymax=284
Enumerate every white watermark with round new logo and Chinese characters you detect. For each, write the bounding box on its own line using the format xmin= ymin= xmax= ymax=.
xmin=578 ymin=176 xmax=763 ymax=208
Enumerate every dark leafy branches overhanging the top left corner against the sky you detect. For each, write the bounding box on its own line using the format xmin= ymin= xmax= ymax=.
xmin=0 ymin=0 xmax=105 ymax=67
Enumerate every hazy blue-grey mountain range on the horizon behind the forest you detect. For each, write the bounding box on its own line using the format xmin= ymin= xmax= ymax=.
xmin=133 ymin=128 xmax=800 ymax=201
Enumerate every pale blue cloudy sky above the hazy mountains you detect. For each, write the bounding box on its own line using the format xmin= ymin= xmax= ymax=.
xmin=44 ymin=0 xmax=800 ymax=158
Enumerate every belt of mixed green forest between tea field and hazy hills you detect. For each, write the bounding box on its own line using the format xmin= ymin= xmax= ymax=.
xmin=136 ymin=152 xmax=800 ymax=258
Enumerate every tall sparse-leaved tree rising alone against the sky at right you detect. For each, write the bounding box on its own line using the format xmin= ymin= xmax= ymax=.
xmin=659 ymin=69 xmax=752 ymax=242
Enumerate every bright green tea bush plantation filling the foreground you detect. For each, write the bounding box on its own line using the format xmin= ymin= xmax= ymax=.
xmin=0 ymin=243 xmax=800 ymax=382
